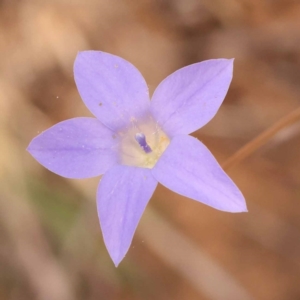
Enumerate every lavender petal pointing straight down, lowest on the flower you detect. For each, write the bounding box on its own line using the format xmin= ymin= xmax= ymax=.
xmin=97 ymin=165 xmax=157 ymax=266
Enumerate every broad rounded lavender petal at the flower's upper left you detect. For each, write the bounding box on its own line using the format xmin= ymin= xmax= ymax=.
xmin=74 ymin=51 xmax=150 ymax=130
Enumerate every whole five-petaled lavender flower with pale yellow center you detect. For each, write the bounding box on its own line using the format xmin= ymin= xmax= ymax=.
xmin=28 ymin=51 xmax=247 ymax=266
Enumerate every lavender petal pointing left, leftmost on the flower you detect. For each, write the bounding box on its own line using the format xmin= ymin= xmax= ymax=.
xmin=27 ymin=118 xmax=118 ymax=178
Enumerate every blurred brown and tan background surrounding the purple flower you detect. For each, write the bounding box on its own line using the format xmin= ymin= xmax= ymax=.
xmin=0 ymin=0 xmax=300 ymax=300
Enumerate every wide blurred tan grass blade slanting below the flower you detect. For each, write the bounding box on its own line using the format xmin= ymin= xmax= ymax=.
xmin=138 ymin=207 xmax=254 ymax=300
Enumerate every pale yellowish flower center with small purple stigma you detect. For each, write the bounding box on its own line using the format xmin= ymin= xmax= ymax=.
xmin=118 ymin=115 xmax=170 ymax=169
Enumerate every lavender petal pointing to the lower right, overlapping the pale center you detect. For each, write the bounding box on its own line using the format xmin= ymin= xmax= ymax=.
xmin=152 ymin=135 xmax=247 ymax=212
